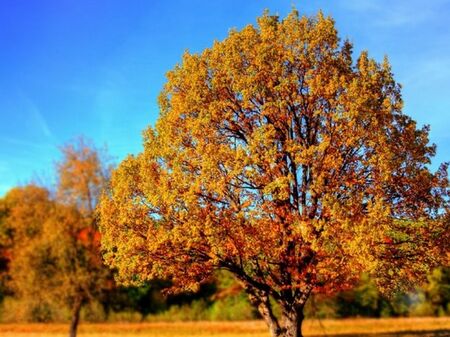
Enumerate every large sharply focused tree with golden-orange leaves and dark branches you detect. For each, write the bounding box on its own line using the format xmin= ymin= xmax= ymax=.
xmin=100 ymin=11 xmax=448 ymax=336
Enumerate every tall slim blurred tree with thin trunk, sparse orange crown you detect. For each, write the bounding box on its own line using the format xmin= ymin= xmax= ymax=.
xmin=55 ymin=138 xmax=112 ymax=337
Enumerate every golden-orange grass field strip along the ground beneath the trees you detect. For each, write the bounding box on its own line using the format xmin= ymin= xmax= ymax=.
xmin=0 ymin=317 xmax=450 ymax=337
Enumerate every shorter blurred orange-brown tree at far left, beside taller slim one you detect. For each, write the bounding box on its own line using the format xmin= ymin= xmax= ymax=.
xmin=2 ymin=185 xmax=59 ymax=321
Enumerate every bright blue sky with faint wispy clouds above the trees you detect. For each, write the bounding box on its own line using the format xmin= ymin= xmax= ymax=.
xmin=0 ymin=0 xmax=450 ymax=195
